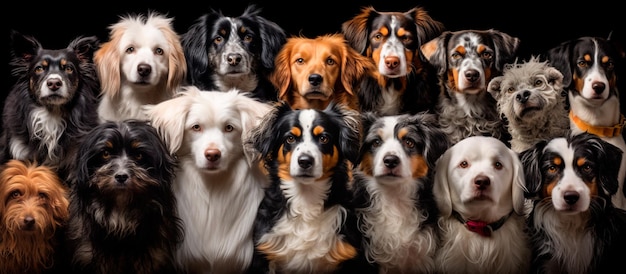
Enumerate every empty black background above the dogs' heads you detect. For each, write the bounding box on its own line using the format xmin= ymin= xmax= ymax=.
xmin=2 ymin=0 xmax=626 ymax=109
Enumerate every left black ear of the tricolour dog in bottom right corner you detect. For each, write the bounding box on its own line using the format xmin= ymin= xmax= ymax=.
xmin=518 ymin=141 xmax=547 ymax=198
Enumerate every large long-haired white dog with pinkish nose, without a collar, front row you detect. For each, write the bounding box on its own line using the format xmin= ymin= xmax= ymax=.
xmin=144 ymin=86 xmax=271 ymax=273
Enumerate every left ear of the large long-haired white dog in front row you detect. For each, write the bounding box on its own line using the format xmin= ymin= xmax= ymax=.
xmin=142 ymin=86 xmax=194 ymax=155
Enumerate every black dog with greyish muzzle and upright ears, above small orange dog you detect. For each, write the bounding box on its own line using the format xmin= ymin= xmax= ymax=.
xmin=0 ymin=31 xmax=100 ymax=180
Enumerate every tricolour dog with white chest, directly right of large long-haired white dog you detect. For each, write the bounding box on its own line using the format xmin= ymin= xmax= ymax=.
xmin=247 ymin=102 xmax=361 ymax=273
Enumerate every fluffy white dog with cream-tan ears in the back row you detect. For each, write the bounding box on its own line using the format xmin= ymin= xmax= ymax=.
xmin=94 ymin=12 xmax=187 ymax=121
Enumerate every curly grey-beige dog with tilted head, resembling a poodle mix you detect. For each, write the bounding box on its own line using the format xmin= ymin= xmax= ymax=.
xmin=487 ymin=57 xmax=570 ymax=153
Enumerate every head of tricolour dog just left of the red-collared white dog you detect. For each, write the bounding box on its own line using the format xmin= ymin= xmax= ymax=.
xmin=358 ymin=113 xmax=449 ymax=183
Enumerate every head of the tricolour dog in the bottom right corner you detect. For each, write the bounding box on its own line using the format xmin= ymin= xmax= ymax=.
xmin=519 ymin=133 xmax=623 ymax=213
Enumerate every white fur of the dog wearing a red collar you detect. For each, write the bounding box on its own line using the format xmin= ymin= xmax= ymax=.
xmin=433 ymin=136 xmax=531 ymax=273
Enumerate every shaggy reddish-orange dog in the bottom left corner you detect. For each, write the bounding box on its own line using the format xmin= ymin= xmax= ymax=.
xmin=0 ymin=160 xmax=69 ymax=273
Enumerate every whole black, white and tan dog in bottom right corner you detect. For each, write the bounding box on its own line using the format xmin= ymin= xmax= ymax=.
xmin=520 ymin=133 xmax=626 ymax=273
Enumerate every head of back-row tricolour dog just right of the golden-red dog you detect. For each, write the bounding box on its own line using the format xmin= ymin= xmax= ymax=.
xmin=342 ymin=6 xmax=444 ymax=78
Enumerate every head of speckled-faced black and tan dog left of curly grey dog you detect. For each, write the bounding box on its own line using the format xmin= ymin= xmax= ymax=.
xmin=421 ymin=29 xmax=520 ymax=94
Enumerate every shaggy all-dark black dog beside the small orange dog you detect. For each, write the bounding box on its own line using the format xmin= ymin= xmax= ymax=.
xmin=67 ymin=120 xmax=183 ymax=274
